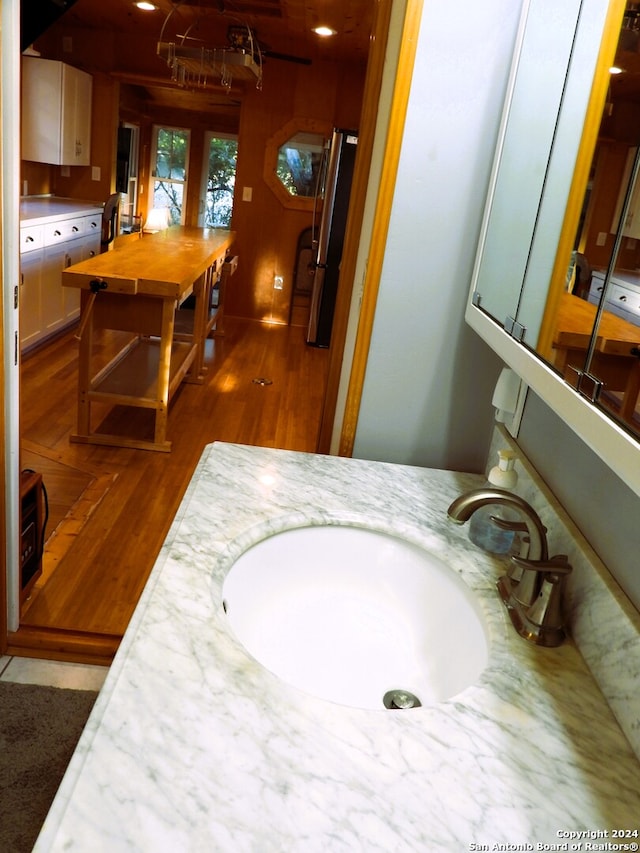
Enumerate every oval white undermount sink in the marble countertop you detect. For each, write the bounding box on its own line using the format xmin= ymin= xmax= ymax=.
xmin=223 ymin=525 xmax=489 ymax=709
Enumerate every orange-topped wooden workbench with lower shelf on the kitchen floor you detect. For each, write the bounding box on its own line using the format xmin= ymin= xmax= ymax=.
xmin=62 ymin=226 xmax=233 ymax=451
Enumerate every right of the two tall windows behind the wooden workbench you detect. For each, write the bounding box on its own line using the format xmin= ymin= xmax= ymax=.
xmin=198 ymin=133 xmax=238 ymax=228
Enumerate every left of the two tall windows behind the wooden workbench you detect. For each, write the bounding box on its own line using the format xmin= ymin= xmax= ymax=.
xmin=151 ymin=127 xmax=189 ymax=225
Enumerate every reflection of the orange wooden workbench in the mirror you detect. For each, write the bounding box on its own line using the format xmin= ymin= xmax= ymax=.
xmin=553 ymin=293 xmax=640 ymax=423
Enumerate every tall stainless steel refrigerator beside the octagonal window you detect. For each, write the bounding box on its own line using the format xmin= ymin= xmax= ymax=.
xmin=307 ymin=130 xmax=358 ymax=347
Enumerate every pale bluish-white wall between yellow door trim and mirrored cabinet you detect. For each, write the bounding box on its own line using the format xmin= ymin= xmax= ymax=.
xmin=353 ymin=0 xmax=520 ymax=471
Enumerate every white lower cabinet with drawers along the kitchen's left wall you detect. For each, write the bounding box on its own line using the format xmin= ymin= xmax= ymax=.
xmin=20 ymin=207 xmax=102 ymax=352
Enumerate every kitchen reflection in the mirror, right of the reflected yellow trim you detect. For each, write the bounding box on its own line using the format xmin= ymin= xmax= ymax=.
xmin=540 ymin=4 xmax=640 ymax=436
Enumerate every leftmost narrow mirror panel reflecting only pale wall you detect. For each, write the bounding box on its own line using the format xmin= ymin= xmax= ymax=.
xmin=468 ymin=0 xmax=593 ymax=328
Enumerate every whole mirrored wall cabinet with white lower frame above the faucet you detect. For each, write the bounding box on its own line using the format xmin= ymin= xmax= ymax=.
xmin=467 ymin=0 xmax=640 ymax=494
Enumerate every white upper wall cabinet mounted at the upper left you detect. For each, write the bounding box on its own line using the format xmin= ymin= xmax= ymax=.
xmin=22 ymin=56 xmax=92 ymax=166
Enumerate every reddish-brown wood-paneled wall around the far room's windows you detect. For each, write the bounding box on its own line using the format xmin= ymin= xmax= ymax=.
xmin=22 ymin=25 xmax=366 ymax=323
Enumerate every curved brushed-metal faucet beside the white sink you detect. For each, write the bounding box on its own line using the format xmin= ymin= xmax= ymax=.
xmin=447 ymin=489 xmax=571 ymax=646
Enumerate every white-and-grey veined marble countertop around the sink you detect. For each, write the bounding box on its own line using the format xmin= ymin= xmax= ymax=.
xmin=35 ymin=443 xmax=640 ymax=853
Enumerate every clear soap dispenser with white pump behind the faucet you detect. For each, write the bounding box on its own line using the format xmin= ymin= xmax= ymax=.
xmin=469 ymin=449 xmax=521 ymax=554
